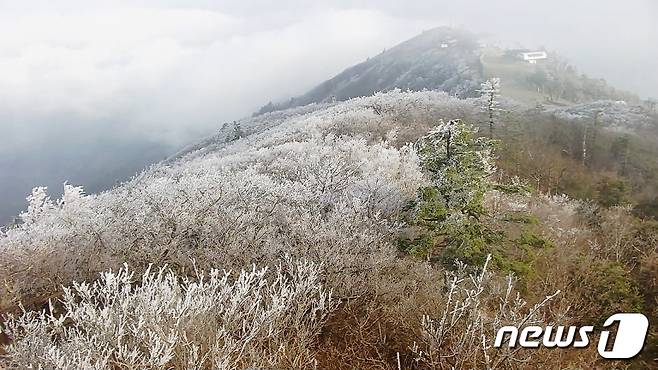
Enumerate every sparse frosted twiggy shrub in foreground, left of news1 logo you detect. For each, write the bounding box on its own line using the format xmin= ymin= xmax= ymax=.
xmin=414 ymin=256 xmax=561 ymax=369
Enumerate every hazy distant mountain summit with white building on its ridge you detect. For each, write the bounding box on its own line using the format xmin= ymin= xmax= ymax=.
xmin=254 ymin=27 xmax=641 ymax=116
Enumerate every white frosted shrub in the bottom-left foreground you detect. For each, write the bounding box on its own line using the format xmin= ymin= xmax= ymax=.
xmin=0 ymin=260 xmax=336 ymax=370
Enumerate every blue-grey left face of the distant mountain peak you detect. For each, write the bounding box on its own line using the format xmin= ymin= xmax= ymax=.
xmin=256 ymin=27 xmax=482 ymax=115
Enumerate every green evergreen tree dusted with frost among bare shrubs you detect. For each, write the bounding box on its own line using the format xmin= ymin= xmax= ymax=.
xmin=402 ymin=120 xmax=495 ymax=263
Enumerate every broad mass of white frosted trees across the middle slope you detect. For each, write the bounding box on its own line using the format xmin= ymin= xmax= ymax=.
xmin=0 ymin=91 xmax=477 ymax=309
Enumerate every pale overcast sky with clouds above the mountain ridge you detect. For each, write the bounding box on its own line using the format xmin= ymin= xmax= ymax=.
xmin=0 ymin=0 xmax=658 ymax=224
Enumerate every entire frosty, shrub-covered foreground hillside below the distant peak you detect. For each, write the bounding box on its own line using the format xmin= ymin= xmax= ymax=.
xmin=0 ymin=90 xmax=658 ymax=370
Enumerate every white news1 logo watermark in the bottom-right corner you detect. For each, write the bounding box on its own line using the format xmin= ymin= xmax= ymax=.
xmin=494 ymin=313 xmax=649 ymax=359
